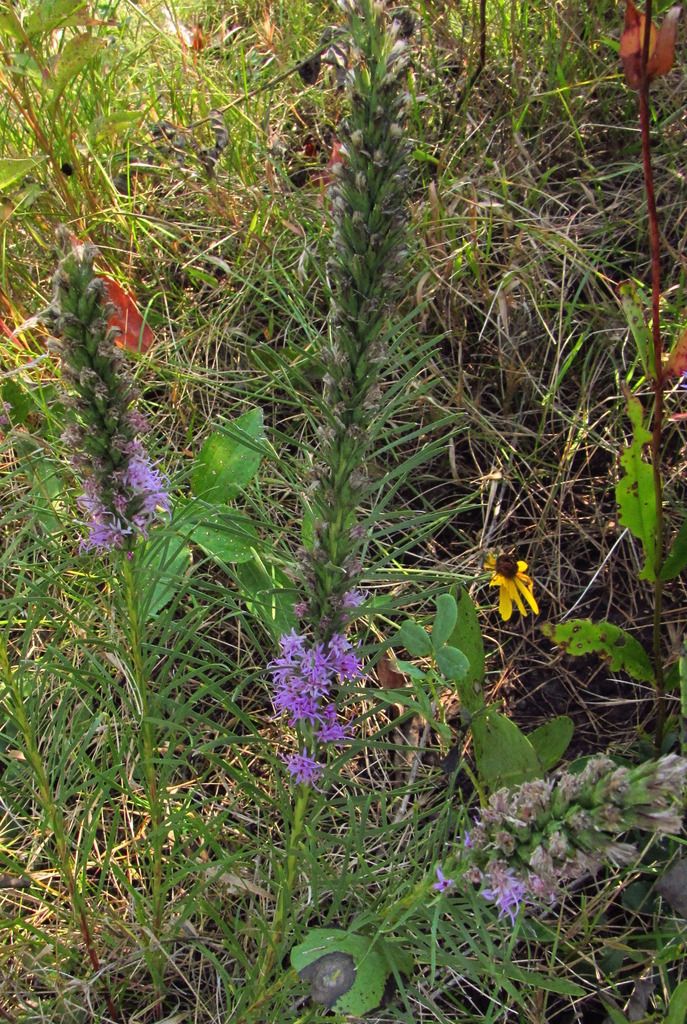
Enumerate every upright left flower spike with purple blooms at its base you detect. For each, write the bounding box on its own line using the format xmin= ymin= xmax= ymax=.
xmin=50 ymin=229 xmax=170 ymax=552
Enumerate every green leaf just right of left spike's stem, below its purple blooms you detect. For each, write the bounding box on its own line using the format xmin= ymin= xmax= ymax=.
xmin=133 ymin=527 xmax=191 ymax=620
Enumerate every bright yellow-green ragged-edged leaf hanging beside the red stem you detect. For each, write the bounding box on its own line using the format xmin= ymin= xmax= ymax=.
xmin=615 ymin=397 xmax=656 ymax=580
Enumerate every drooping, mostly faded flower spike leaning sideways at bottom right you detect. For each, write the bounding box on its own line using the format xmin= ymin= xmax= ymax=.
xmin=434 ymin=754 xmax=687 ymax=922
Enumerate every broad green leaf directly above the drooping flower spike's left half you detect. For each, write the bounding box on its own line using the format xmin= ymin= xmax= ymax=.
xmin=471 ymin=708 xmax=542 ymax=790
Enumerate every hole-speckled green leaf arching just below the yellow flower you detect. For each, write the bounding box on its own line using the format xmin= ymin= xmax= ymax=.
xmin=542 ymin=618 xmax=654 ymax=683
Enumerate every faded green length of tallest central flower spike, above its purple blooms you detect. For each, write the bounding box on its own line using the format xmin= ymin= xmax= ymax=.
xmin=304 ymin=0 xmax=409 ymax=635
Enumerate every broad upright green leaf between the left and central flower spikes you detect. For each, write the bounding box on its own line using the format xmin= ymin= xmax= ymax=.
xmin=190 ymin=409 xmax=264 ymax=503
